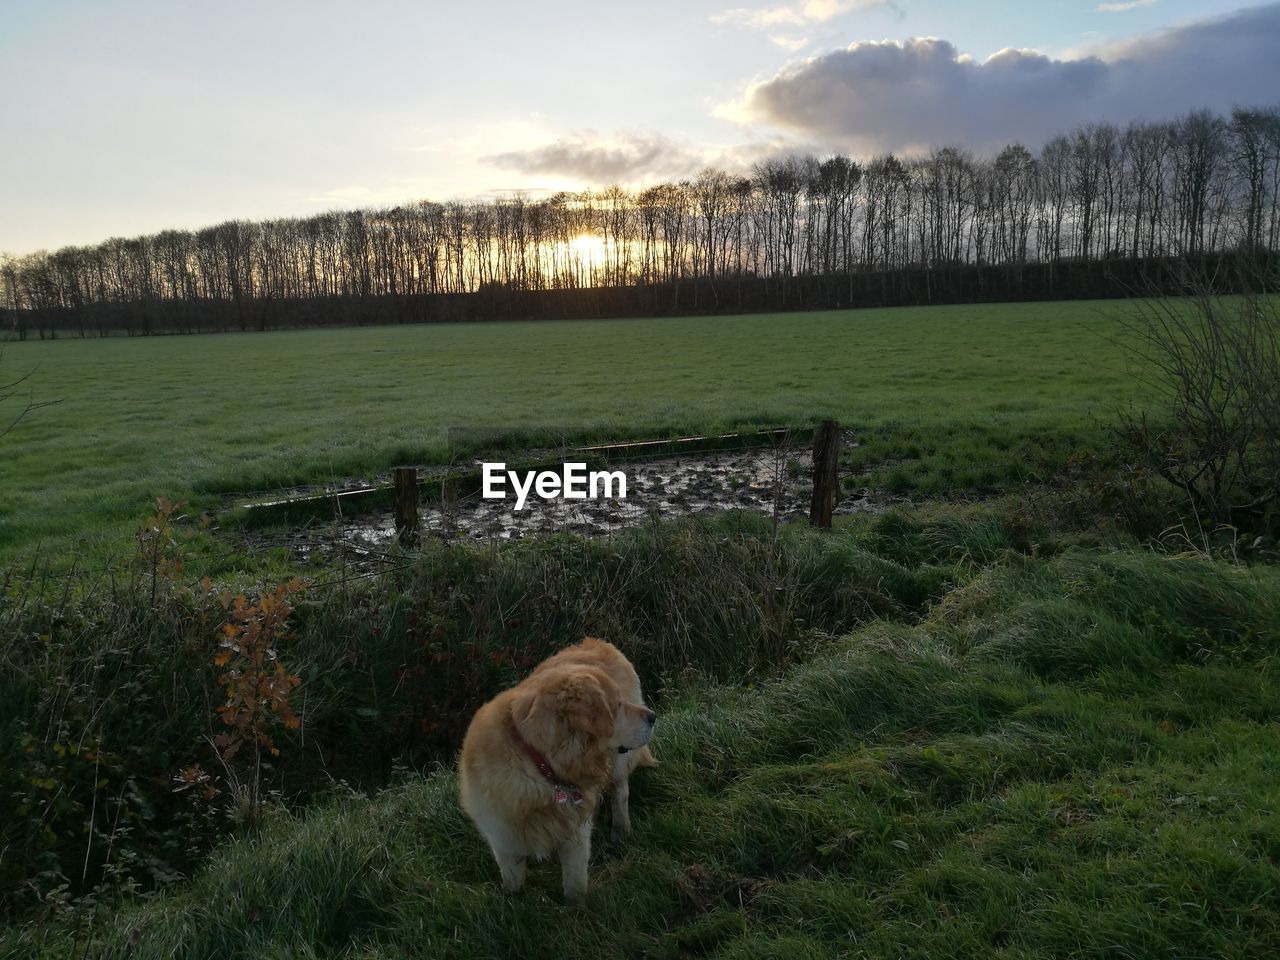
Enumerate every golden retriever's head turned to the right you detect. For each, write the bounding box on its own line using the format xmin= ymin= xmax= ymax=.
xmin=512 ymin=668 xmax=657 ymax=751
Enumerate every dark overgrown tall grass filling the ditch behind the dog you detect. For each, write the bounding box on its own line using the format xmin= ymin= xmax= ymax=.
xmin=0 ymin=515 xmax=951 ymax=909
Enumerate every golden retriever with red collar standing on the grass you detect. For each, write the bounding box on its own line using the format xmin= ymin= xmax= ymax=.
xmin=458 ymin=637 xmax=657 ymax=904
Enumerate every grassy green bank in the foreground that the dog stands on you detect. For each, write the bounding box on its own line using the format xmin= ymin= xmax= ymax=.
xmin=9 ymin=506 xmax=1280 ymax=957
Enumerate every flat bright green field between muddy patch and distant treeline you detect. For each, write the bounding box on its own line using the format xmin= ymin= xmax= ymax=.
xmin=0 ymin=302 xmax=1135 ymax=558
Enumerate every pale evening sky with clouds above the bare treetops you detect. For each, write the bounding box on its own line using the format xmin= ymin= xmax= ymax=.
xmin=0 ymin=0 xmax=1280 ymax=255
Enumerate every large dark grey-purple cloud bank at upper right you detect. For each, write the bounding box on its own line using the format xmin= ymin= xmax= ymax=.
xmin=737 ymin=3 xmax=1280 ymax=154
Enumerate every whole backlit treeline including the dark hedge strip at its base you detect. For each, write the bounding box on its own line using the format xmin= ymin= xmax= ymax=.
xmin=0 ymin=108 xmax=1280 ymax=337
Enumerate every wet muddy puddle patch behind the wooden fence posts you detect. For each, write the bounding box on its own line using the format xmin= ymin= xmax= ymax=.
xmin=314 ymin=449 xmax=887 ymax=550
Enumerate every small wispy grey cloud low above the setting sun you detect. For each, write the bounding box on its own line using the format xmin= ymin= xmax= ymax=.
xmin=483 ymin=133 xmax=703 ymax=184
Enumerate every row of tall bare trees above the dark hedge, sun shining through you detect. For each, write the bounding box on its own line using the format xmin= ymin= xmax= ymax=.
xmin=0 ymin=108 xmax=1280 ymax=330
